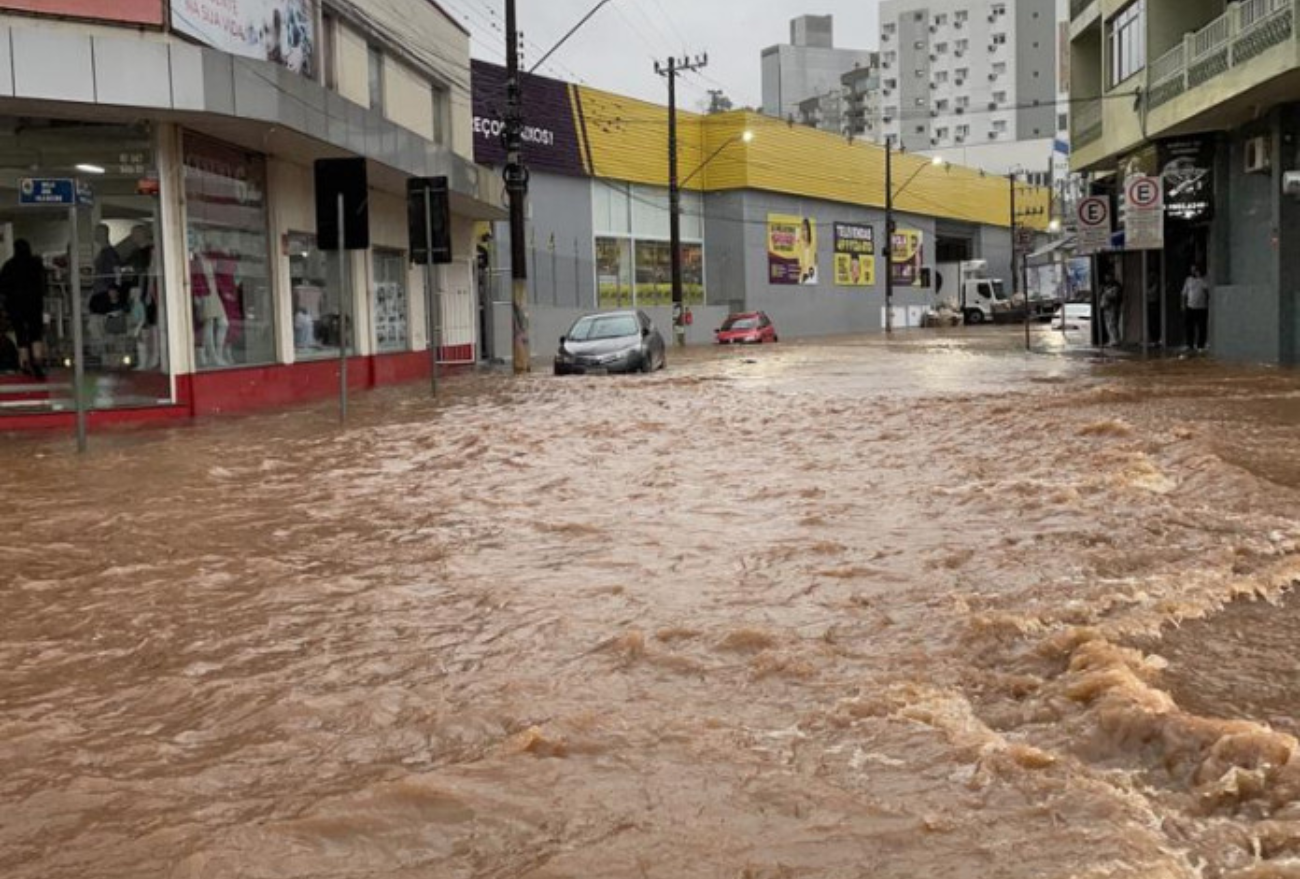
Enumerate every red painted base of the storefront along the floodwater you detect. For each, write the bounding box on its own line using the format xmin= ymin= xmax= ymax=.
xmin=0 ymin=345 xmax=475 ymax=433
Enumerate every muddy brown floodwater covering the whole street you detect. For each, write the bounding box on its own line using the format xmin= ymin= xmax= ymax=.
xmin=0 ymin=332 xmax=1300 ymax=879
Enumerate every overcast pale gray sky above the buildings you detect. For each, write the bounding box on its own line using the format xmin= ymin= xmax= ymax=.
xmin=438 ymin=0 xmax=879 ymax=108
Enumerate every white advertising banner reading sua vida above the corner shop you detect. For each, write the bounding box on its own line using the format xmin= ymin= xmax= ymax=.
xmin=172 ymin=0 xmax=316 ymax=77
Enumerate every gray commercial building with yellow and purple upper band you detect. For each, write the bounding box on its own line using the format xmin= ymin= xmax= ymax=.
xmin=475 ymin=61 xmax=1011 ymax=360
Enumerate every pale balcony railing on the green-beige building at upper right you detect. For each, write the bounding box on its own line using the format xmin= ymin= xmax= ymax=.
xmin=1147 ymin=0 xmax=1300 ymax=109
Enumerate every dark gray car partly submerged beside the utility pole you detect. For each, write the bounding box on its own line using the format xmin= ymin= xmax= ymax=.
xmin=555 ymin=311 xmax=668 ymax=376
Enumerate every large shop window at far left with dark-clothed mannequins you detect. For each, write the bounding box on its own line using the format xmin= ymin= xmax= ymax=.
xmin=0 ymin=117 xmax=172 ymax=412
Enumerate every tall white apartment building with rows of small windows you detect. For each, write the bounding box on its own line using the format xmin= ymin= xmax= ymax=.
xmin=880 ymin=0 xmax=1069 ymax=179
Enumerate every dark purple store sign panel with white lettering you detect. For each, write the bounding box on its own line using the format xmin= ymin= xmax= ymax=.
xmin=473 ymin=61 xmax=588 ymax=177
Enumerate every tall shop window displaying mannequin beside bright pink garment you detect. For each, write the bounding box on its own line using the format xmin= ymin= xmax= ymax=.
xmin=185 ymin=135 xmax=276 ymax=369
